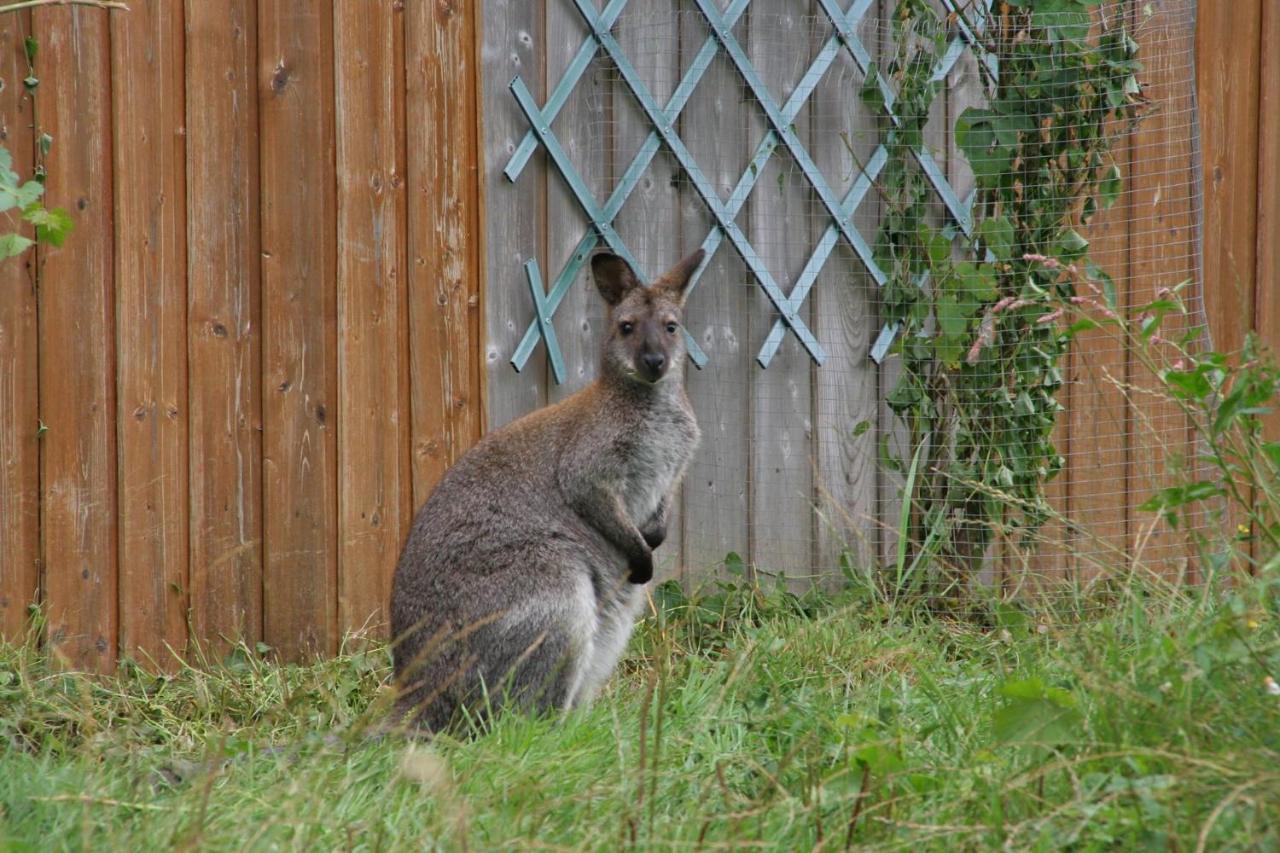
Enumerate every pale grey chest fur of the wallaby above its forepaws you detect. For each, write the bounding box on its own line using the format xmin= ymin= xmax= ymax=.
xmin=621 ymin=405 xmax=699 ymax=526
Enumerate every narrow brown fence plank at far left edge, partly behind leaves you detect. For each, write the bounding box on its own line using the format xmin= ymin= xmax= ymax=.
xmin=0 ymin=12 xmax=40 ymax=640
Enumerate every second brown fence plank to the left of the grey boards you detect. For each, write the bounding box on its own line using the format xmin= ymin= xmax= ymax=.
xmin=334 ymin=0 xmax=412 ymax=634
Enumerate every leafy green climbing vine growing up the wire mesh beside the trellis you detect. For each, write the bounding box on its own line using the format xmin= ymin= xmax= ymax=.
xmin=864 ymin=0 xmax=1143 ymax=590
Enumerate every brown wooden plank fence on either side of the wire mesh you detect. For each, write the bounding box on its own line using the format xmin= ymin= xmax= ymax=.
xmin=0 ymin=0 xmax=1280 ymax=670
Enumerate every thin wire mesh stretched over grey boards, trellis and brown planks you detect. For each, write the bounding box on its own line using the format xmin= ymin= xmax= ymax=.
xmin=490 ymin=0 xmax=1210 ymax=593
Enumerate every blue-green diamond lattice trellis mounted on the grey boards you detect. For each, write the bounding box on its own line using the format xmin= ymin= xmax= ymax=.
xmin=504 ymin=0 xmax=997 ymax=383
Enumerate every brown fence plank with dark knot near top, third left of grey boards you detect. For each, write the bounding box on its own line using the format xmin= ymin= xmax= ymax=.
xmin=259 ymin=0 xmax=338 ymax=660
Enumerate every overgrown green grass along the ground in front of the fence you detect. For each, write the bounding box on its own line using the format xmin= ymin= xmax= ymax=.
xmin=0 ymin=573 xmax=1280 ymax=850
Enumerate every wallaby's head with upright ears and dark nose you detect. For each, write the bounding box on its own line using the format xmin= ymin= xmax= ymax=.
xmin=591 ymin=248 xmax=705 ymax=384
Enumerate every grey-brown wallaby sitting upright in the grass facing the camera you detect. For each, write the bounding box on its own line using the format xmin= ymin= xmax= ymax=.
xmin=390 ymin=250 xmax=704 ymax=731
